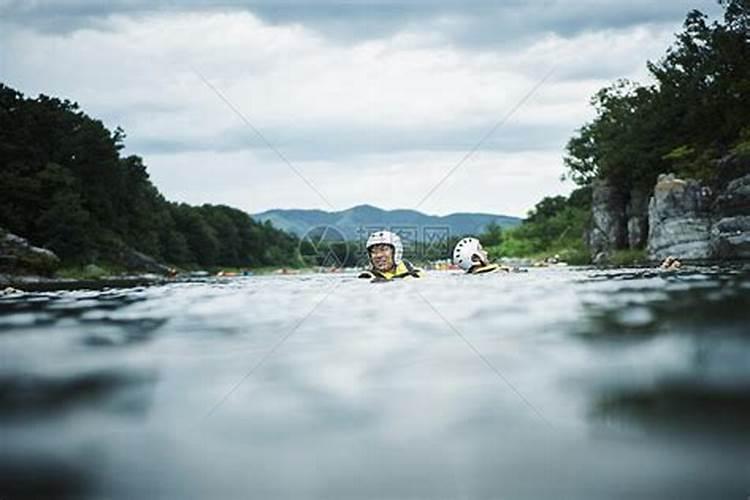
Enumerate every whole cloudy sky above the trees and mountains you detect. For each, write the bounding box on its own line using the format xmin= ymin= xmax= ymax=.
xmin=0 ymin=0 xmax=719 ymax=215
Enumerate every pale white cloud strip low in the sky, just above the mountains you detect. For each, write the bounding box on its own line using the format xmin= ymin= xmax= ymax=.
xmin=151 ymin=151 xmax=573 ymax=216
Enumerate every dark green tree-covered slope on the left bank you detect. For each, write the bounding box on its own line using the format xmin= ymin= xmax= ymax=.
xmin=0 ymin=84 xmax=299 ymax=267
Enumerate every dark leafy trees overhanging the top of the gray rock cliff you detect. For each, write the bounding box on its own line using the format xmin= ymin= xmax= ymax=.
xmin=565 ymin=0 xmax=750 ymax=188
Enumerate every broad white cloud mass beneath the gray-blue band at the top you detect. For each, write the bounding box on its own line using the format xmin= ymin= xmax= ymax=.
xmin=0 ymin=7 xmax=688 ymax=214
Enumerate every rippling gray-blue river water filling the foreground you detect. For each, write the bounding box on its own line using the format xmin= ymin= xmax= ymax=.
xmin=0 ymin=267 xmax=750 ymax=500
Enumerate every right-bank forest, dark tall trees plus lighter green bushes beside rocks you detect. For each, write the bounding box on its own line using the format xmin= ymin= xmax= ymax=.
xmin=483 ymin=0 xmax=750 ymax=263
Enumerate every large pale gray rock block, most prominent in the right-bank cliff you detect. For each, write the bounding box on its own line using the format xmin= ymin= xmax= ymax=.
xmin=648 ymin=174 xmax=714 ymax=260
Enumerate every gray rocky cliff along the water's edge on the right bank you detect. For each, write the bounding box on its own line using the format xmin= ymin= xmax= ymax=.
xmin=588 ymin=161 xmax=750 ymax=264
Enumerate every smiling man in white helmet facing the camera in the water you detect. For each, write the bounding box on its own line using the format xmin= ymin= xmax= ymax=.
xmin=359 ymin=231 xmax=422 ymax=281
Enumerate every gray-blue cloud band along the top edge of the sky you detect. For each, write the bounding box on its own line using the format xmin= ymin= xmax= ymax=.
xmin=0 ymin=0 xmax=720 ymax=46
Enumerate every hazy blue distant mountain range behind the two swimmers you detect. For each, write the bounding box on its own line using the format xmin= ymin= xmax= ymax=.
xmin=252 ymin=205 xmax=521 ymax=241
